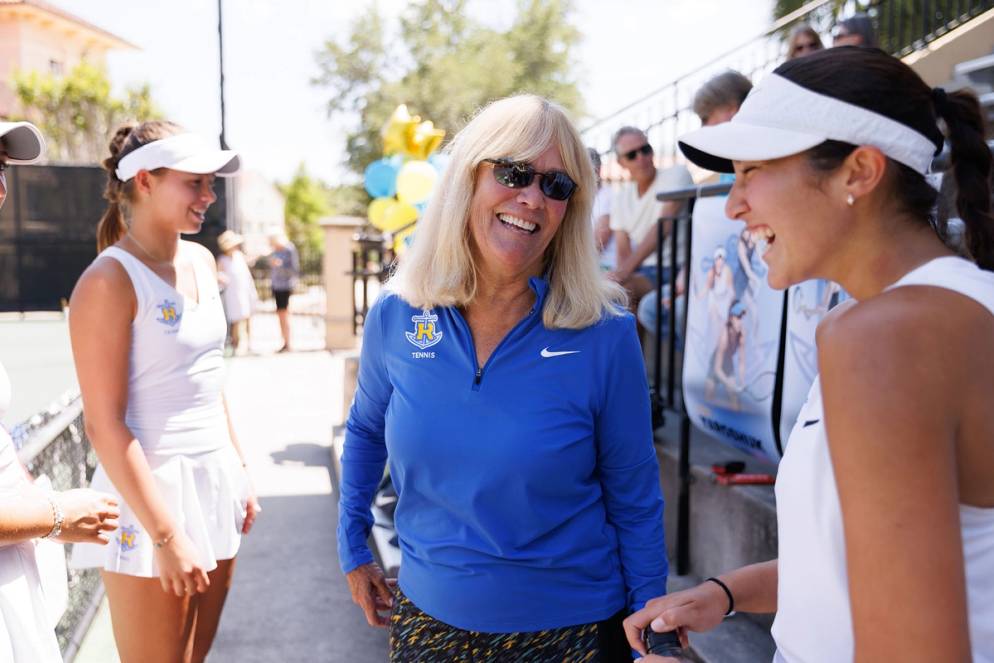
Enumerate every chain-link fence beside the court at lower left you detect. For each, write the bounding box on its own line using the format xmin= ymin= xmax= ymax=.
xmin=14 ymin=393 xmax=103 ymax=661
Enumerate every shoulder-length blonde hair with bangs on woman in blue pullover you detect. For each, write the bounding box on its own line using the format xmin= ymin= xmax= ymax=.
xmin=388 ymin=95 xmax=627 ymax=329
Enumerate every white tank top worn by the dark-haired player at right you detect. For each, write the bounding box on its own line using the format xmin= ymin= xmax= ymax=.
xmin=773 ymin=257 xmax=994 ymax=663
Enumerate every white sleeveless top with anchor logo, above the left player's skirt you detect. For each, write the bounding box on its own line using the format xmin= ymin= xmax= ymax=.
xmin=98 ymin=246 xmax=230 ymax=454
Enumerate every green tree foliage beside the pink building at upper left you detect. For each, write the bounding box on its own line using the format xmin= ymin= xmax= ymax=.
xmin=14 ymin=62 xmax=160 ymax=164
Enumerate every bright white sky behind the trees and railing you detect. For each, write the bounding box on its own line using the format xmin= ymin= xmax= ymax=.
xmin=42 ymin=0 xmax=771 ymax=183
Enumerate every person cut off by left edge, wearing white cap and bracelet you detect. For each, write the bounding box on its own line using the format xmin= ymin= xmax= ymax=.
xmin=0 ymin=122 xmax=119 ymax=663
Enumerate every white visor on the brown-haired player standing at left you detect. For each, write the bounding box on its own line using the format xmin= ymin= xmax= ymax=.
xmin=116 ymin=134 xmax=241 ymax=182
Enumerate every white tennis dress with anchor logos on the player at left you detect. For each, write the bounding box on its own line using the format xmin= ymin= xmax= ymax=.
xmin=70 ymin=247 xmax=248 ymax=577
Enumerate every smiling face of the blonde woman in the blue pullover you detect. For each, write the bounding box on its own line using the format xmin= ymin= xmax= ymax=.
xmin=469 ymin=146 xmax=568 ymax=278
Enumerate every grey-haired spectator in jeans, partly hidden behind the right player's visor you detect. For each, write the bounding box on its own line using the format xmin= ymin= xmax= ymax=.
xmin=638 ymin=69 xmax=752 ymax=342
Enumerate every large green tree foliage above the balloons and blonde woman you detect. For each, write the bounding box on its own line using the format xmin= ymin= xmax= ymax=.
xmin=314 ymin=0 xmax=582 ymax=173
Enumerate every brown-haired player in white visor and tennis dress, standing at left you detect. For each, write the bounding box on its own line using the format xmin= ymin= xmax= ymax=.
xmin=69 ymin=121 xmax=259 ymax=663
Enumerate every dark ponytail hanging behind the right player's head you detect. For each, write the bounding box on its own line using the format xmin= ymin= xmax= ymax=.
xmin=932 ymin=88 xmax=994 ymax=270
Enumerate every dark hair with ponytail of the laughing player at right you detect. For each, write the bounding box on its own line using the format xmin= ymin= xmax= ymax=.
xmin=774 ymin=47 xmax=994 ymax=270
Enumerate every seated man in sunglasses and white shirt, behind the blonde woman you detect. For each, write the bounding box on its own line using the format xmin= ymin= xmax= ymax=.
xmin=611 ymin=127 xmax=694 ymax=326
